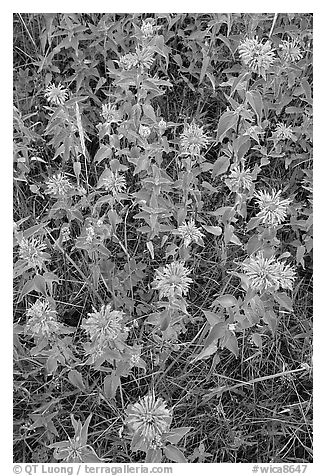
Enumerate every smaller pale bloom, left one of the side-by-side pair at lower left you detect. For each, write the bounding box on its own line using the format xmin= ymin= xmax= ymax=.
xmin=25 ymin=299 xmax=60 ymax=337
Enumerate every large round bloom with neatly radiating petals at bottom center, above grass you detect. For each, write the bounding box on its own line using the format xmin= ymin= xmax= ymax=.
xmin=125 ymin=394 xmax=172 ymax=448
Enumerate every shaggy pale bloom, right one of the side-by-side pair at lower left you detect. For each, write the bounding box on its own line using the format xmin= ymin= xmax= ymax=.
xmin=81 ymin=304 xmax=128 ymax=347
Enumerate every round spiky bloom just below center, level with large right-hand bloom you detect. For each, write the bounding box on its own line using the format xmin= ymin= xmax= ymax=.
xmin=153 ymin=262 xmax=193 ymax=299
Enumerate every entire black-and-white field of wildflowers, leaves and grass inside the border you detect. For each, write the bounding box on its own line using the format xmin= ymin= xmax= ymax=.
xmin=13 ymin=13 xmax=312 ymax=463
